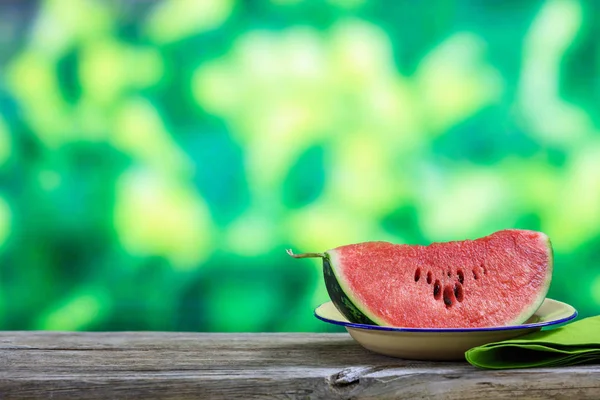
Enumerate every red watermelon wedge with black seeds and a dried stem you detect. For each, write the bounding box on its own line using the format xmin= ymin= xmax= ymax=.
xmin=288 ymin=229 xmax=553 ymax=328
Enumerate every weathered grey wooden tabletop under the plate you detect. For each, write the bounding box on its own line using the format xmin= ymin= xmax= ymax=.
xmin=0 ymin=332 xmax=600 ymax=400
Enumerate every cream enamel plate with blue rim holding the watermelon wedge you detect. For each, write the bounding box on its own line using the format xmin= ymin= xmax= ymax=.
xmin=315 ymin=299 xmax=577 ymax=360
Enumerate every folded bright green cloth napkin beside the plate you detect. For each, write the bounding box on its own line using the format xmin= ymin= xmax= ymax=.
xmin=465 ymin=316 xmax=600 ymax=369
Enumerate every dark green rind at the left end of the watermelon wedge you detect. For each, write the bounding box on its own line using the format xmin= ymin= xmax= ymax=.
xmin=323 ymin=252 xmax=384 ymax=325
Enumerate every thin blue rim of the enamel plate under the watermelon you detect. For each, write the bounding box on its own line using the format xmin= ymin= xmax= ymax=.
xmin=313 ymin=299 xmax=579 ymax=333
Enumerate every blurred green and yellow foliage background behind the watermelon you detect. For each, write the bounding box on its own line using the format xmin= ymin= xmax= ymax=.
xmin=0 ymin=0 xmax=600 ymax=331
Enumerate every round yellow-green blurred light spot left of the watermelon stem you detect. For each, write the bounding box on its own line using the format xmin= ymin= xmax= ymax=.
xmin=114 ymin=168 xmax=213 ymax=269
